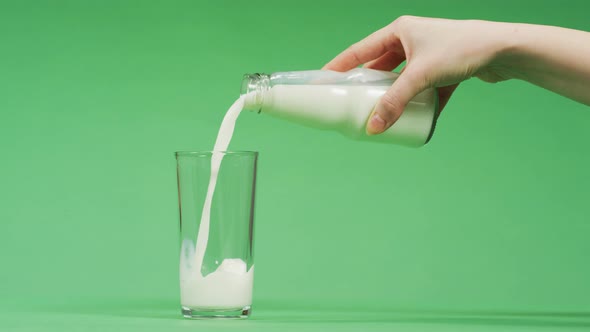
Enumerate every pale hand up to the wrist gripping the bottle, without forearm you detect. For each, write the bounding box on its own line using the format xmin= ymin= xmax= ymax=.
xmin=324 ymin=16 xmax=510 ymax=135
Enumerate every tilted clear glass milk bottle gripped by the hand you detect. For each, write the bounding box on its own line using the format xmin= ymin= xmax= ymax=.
xmin=242 ymin=69 xmax=438 ymax=147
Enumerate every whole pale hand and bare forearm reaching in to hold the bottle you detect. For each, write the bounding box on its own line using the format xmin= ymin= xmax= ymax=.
xmin=324 ymin=16 xmax=590 ymax=135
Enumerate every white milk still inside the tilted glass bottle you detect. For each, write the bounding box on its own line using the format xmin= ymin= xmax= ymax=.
xmin=245 ymin=84 xmax=436 ymax=146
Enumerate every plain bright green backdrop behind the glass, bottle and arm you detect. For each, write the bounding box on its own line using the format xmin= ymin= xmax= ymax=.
xmin=0 ymin=0 xmax=590 ymax=330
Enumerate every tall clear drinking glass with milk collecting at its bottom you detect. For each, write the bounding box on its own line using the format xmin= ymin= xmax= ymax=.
xmin=176 ymin=151 xmax=258 ymax=318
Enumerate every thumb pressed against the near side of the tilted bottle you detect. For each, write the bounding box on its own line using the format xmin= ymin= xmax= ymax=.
xmin=367 ymin=66 xmax=428 ymax=135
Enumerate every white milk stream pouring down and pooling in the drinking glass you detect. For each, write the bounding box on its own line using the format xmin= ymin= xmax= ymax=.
xmin=180 ymin=97 xmax=254 ymax=309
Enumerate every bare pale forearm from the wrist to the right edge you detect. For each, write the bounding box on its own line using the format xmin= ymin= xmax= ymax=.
xmin=497 ymin=24 xmax=590 ymax=105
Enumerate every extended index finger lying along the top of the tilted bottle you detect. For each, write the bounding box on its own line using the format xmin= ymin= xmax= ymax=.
xmin=323 ymin=25 xmax=403 ymax=71
